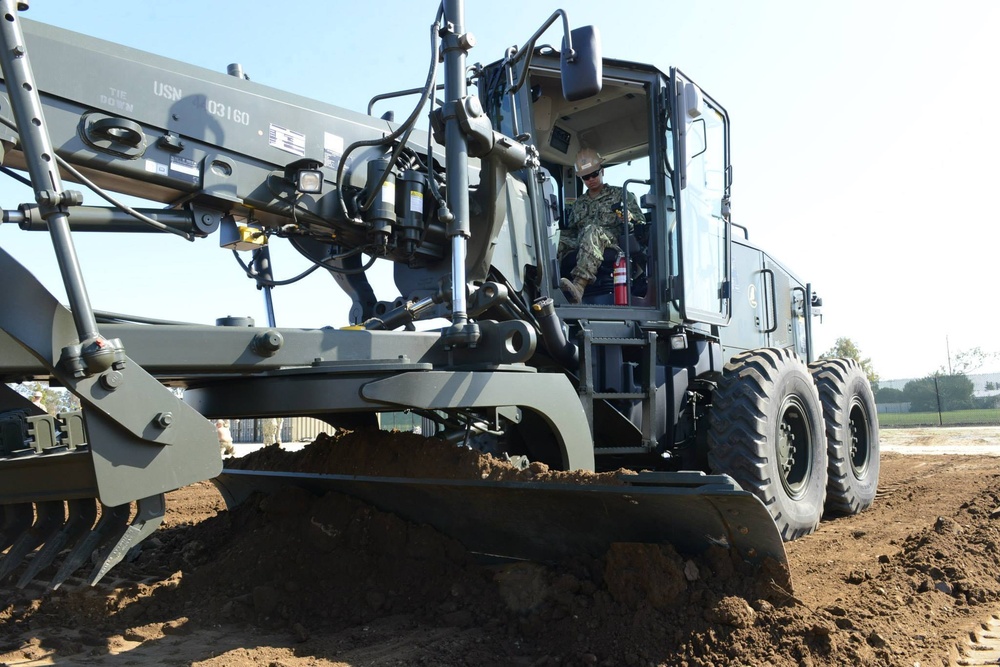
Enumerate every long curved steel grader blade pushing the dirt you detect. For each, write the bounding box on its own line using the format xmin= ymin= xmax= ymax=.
xmin=212 ymin=470 xmax=790 ymax=589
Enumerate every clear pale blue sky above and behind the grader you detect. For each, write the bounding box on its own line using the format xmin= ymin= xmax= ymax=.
xmin=0 ymin=0 xmax=1000 ymax=379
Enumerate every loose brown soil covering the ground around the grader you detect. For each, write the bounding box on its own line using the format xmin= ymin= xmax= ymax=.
xmin=0 ymin=429 xmax=1000 ymax=667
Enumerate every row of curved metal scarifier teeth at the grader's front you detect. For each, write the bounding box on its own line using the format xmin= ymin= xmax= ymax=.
xmin=0 ymin=493 xmax=166 ymax=589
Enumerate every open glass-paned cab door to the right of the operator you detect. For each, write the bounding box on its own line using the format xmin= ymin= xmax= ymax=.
xmin=670 ymin=68 xmax=732 ymax=325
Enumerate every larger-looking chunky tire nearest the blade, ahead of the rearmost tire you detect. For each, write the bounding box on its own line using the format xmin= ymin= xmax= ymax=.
xmin=708 ymin=348 xmax=827 ymax=542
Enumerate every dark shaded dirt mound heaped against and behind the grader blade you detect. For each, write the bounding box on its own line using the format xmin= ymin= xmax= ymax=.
xmin=184 ymin=432 xmax=787 ymax=664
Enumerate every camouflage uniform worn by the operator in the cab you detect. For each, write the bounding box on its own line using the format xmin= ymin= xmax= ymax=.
xmin=558 ymin=184 xmax=644 ymax=282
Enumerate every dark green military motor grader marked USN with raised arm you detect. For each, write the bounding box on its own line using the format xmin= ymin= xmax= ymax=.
xmin=0 ymin=0 xmax=879 ymax=586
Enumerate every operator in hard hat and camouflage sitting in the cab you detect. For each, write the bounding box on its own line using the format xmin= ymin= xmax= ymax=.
xmin=557 ymin=148 xmax=644 ymax=303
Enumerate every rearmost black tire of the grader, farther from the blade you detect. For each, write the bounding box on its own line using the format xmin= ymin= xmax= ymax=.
xmin=809 ymin=359 xmax=879 ymax=516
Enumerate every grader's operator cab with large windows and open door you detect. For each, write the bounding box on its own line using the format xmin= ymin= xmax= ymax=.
xmin=480 ymin=48 xmax=730 ymax=324
